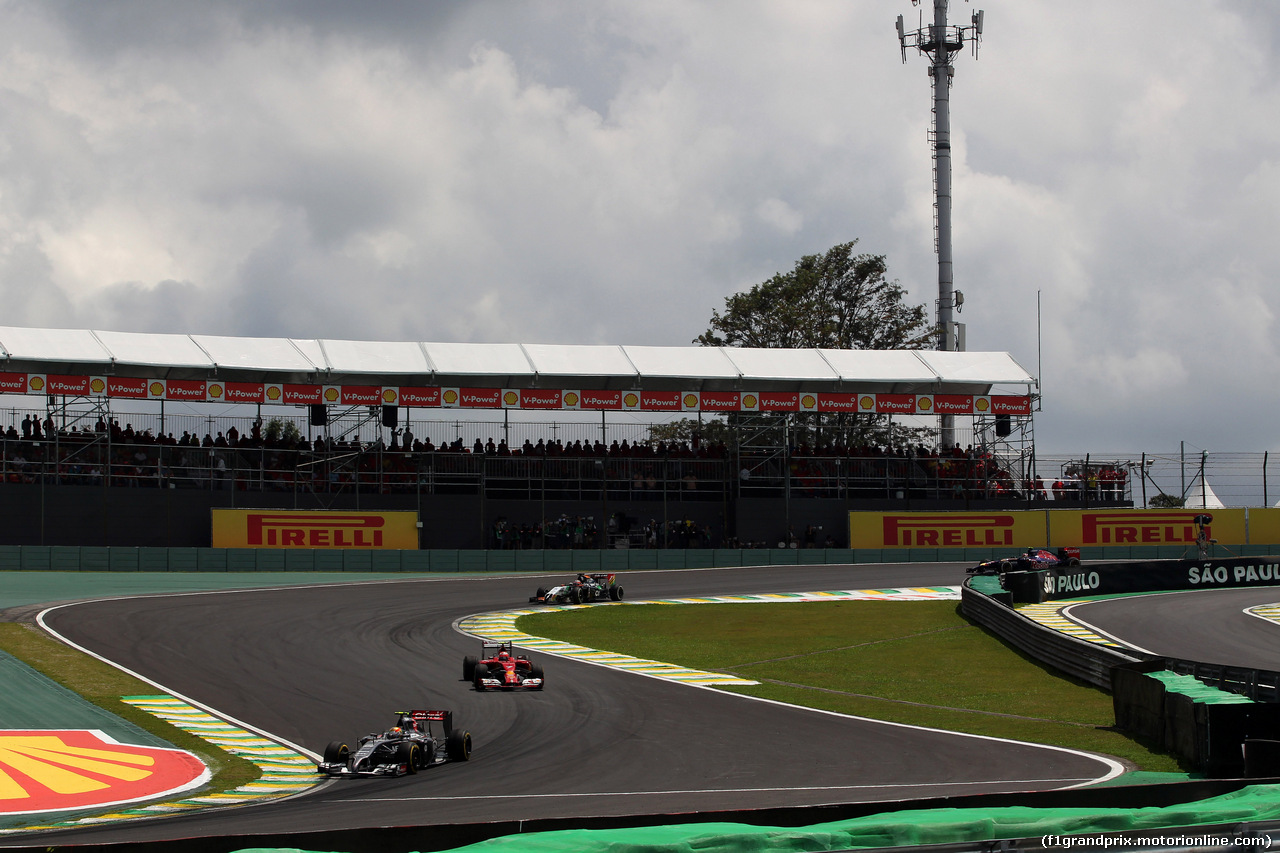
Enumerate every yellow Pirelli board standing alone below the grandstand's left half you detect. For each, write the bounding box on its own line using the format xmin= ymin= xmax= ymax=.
xmin=212 ymin=510 xmax=417 ymax=551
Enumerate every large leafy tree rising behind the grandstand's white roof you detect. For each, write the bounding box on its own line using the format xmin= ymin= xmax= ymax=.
xmin=694 ymin=240 xmax=936 ymax=350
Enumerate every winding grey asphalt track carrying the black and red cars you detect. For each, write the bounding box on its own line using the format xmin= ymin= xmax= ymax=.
xmin=22 ymin=564 xmax=1108 ymax=844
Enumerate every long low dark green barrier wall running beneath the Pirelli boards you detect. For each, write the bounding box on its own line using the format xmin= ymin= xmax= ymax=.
xmin=0 ymin=546 xmax=1280 ymax=573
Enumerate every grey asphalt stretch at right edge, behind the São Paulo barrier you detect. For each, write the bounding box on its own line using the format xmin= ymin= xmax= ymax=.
xmin=1070 ymin=587 xmax=1280 ymax=671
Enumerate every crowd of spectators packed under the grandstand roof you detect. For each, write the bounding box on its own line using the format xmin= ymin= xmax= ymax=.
xmin=0 ymin=415 xmax=1126 ymax=502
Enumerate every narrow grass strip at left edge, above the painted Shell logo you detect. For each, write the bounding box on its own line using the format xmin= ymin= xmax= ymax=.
xmin=0 ymin=622 xmax=262 ymax=790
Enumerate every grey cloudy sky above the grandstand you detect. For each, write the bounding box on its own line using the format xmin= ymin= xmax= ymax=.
xmin=0 ymin=0 xmax=1280 ymax=453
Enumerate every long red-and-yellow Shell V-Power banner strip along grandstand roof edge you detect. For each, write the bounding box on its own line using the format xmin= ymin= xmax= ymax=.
xmin=0 ymin=373 xmax=1032 ymax=415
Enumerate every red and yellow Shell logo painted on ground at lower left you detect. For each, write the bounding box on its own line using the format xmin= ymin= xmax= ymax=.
xmin=0 ymin=730 xmax=209 ymax=815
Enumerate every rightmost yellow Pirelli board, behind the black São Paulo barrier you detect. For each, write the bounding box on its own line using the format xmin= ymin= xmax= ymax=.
xmin=1048 ymin=510 xmax=1258 ymax=547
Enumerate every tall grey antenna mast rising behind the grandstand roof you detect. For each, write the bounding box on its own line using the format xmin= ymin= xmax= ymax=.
xmin=897 ymin=0 xmax=983 ymax=450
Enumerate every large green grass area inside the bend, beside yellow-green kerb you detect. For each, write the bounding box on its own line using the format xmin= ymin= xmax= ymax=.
xmin=516 ymin=601 xmax=1181 ymax=772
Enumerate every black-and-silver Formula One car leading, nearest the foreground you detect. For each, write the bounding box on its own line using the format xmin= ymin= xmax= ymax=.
xmin=316 ymin=711 xmax=471 ymax=776
